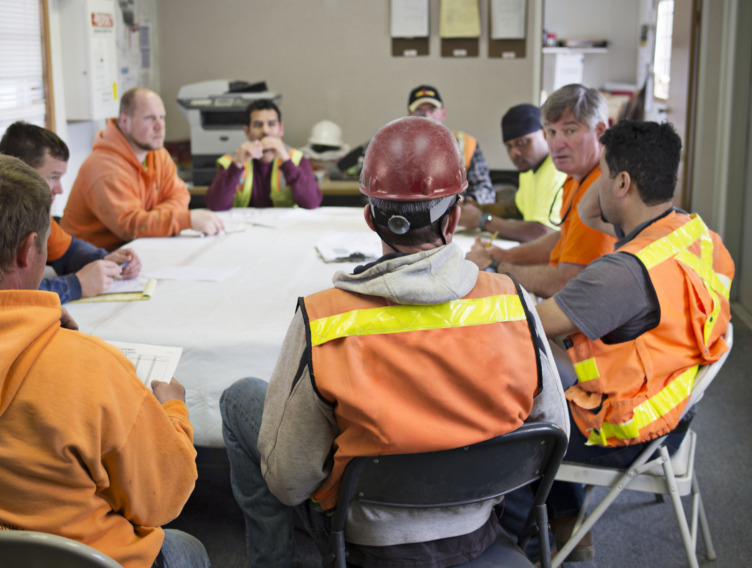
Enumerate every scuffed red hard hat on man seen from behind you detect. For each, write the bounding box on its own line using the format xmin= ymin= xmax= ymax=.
xmin=360 ymin=116 xmax=467 ymax=201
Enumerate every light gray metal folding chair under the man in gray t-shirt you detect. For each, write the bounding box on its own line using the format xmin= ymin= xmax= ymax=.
xmin=552 ymin=324 xmax=734 ymax=568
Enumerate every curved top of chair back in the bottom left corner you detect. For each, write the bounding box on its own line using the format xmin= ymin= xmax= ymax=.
xmin=0 ymin=530 xmax=122 ymax=568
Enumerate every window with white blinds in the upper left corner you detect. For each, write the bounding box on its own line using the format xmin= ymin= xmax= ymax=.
xmin=0 ymin=0 xmax=47 ymax=136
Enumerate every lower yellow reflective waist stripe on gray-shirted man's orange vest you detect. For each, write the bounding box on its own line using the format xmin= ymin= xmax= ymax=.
xmin=586 ymin=365 xmax=699 ymax=446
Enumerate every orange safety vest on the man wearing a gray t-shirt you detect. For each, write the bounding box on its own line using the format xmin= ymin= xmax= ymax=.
xmin=565 ymin=211 xmax=734 ymax=446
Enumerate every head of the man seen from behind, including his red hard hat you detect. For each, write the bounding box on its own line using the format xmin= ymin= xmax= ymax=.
xmin=360 ymin=116 xmax=467 ymax=248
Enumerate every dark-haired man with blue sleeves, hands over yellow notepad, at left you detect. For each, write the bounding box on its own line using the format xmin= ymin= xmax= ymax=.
xmin=0 ymin=121 xmax=141 ymax=304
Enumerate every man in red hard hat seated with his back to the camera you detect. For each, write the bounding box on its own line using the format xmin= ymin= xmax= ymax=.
xmin=220 ymin=117 xmax=566 ymax=568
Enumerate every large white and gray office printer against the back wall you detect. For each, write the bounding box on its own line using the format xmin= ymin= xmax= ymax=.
xmin=178 ymin=80 xmax=281 ymax=185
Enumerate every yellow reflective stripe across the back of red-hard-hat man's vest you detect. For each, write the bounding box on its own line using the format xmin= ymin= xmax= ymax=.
xmin=310 ymin=294 xmax=526 ymax=346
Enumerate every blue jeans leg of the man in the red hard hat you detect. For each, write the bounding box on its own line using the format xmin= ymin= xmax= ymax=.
xmin=219 ymin=378 xmax=329 ymax=568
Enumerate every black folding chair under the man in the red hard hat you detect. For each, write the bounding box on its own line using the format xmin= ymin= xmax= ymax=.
xmin=324 ymin=423 xmax=567 ymax=568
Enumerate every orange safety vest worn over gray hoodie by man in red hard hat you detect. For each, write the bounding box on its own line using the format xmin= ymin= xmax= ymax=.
xmin=300 ymin=272 xmax=542 ymax=509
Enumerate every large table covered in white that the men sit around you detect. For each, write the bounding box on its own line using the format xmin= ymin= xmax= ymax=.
xmin=67 ymin=207 xmax=506 ymax=447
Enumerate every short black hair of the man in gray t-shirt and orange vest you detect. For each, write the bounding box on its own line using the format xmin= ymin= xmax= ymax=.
xmin=600 ymin=121 xmax=681 ymax=205
